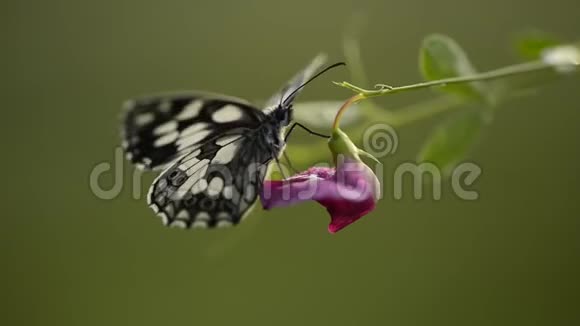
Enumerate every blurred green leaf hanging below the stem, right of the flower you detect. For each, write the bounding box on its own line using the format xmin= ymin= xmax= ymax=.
xmin=417 ymin=111 xmax=483 ymax=175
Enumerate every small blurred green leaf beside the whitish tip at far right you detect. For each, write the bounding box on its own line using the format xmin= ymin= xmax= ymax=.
xmin=514 ymin=30 xmax=562 ymax=60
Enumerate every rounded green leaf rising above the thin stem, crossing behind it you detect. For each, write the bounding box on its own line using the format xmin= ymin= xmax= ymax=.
xmin=419 ymin=34 xmax=489 ymax=100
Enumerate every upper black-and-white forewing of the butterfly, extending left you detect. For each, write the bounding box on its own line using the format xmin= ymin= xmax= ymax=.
xmin=122 ymin=92 xmax=264 ymax=170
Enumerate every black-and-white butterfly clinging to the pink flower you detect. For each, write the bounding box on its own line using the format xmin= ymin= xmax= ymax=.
xmin=122 ymin=55 xmax=344 ymax=228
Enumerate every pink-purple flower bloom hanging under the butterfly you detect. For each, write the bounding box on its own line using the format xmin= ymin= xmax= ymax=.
xmin=260 ymin=159 xmax=380 ymax=233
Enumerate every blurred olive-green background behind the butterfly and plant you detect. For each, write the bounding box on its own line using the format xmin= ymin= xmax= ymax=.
xmin=0 ymin=0 xmax=580 ymax=325
